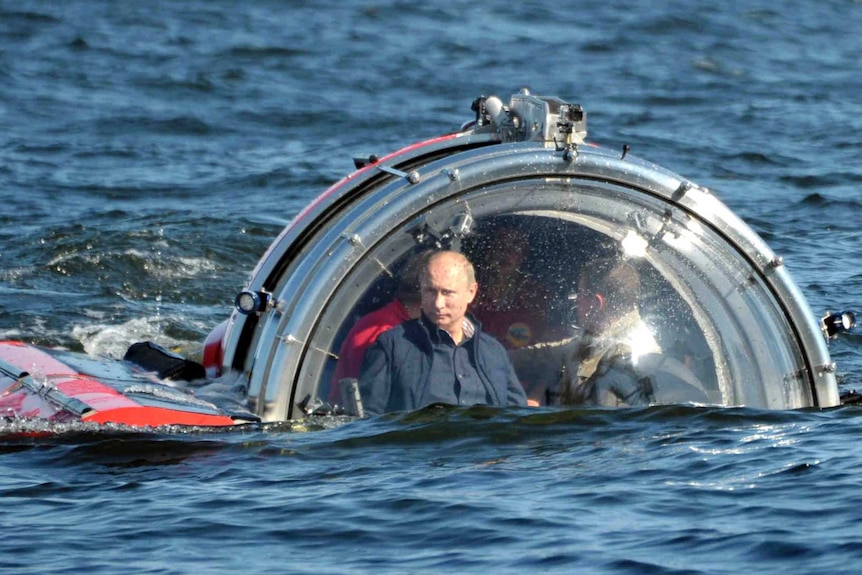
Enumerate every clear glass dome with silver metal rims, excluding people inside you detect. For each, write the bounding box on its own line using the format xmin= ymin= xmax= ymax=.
xmin=214 ymin=93 xmax=838 ymax=420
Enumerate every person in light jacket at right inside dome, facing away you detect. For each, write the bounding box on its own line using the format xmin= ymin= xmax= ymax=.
xmin=510 ymin=257 xmax=708 ymax=407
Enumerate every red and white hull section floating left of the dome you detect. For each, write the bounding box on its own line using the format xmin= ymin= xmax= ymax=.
xmin=0 ymin=342 xmax=235 ymax=427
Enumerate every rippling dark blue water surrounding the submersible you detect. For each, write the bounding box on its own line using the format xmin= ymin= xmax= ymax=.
xmin=0 ymin=0 xmax=862 ymax=574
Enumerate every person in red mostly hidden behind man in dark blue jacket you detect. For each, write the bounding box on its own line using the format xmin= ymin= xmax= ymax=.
xmin=327 ymin=252 xmax=430 ymax=404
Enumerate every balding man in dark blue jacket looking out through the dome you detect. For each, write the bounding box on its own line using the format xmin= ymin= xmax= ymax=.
xmin=359 ymin=251 xmax=527 ymax=415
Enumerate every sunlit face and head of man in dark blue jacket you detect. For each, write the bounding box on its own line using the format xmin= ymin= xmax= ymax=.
xmin=422 ymin=255 xmax=478 ymax=333
